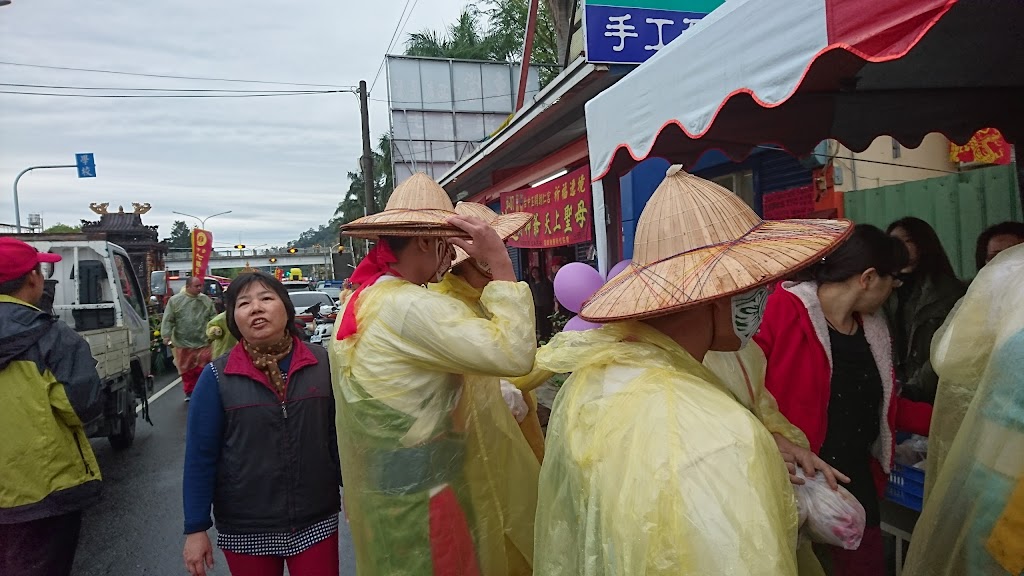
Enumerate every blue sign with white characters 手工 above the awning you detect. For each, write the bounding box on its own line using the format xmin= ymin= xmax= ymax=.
xmin=584 ymin=0 xmax=724 ymax=64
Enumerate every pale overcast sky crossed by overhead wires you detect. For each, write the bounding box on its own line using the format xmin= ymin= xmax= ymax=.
xmin=0 ymin=0 xmax=465 ymax=246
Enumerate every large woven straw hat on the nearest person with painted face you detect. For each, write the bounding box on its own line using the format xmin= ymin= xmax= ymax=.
xmin=580 ymin=166 xmax=853 ymax=322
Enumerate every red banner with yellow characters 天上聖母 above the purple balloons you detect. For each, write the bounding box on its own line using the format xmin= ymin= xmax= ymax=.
xmin=501 ymin=166 xmax=594 ymax=248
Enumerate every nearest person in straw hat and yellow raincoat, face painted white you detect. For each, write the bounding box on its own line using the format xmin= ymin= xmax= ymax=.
xmin=535 ymin=166 xmax=850 ymax=576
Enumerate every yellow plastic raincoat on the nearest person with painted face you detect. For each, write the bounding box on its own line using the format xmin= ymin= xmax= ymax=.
xmin=535 ymin=322 xmax=798 ymax=576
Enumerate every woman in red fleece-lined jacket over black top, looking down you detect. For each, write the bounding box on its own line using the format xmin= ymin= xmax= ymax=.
xmin=754 ymin=224 xmax=931 ymax=576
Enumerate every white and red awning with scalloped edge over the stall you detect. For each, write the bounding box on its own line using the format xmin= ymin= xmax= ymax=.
xmin=587 ymin=0 xmax=1024 ymax=179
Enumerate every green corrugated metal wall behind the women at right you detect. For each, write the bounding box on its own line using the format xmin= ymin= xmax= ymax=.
xmin=844 ymin=164 xmax=1022 ymax=279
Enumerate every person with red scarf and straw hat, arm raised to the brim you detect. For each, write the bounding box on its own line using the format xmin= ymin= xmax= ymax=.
xmin=331 ymin=174 xmax=537 ymax=576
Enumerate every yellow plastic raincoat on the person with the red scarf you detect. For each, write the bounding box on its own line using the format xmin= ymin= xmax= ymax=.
xmin=331 ymin=277 xmax=537 ymax=576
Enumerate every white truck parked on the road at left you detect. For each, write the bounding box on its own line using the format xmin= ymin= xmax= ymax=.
xmin=18 ymin=234 xmax=153 ymax=450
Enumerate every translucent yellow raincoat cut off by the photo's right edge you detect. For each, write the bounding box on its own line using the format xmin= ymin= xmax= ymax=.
xmin=903 ymin=245 xmax=1024 ymax=576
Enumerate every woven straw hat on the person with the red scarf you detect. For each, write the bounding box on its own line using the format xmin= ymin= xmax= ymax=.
xmin=341 ymin=172 xmax=469 ymax=240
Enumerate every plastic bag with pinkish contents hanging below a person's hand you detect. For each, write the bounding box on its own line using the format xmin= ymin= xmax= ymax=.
xmin=794 ymin=467 xmax=867 ymax=550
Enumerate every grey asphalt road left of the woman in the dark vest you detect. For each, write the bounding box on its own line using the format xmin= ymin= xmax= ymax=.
xmin=74 ymin=368 xmax=355 ymax=576
